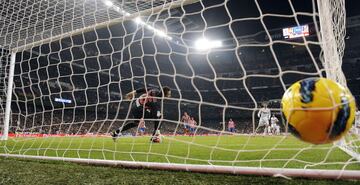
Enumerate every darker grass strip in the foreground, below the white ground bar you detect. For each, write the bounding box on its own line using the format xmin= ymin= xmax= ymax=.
xmin=0 ymin=157 xmax=359 ymax=185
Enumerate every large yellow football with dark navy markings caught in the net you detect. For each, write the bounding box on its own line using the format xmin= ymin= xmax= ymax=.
xmin=281 ymin=78 xmax=356 ymax=144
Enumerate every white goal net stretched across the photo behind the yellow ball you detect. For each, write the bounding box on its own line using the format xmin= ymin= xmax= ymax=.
xmin=0 ymin=0 xmax=360 ymax=178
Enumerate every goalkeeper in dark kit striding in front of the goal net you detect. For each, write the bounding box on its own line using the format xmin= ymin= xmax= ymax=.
xmin=111 ymin=86 xmax=171 ymax=141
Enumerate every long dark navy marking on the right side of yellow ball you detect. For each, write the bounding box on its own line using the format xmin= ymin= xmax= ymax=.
xmin=328 ymin=96 xmax=350 ymax=139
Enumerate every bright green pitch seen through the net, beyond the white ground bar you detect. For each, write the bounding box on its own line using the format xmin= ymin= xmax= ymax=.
xmin=0 ymin=135 xmax=360 ymax=170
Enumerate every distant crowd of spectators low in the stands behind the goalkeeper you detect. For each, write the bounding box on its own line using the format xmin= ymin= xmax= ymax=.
xmin=6 ymin=109 xmax=264 ymax=135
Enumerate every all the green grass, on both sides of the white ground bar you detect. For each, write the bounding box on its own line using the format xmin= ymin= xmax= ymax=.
xmin=0 ymin=135 xmax=360 ymax=184
